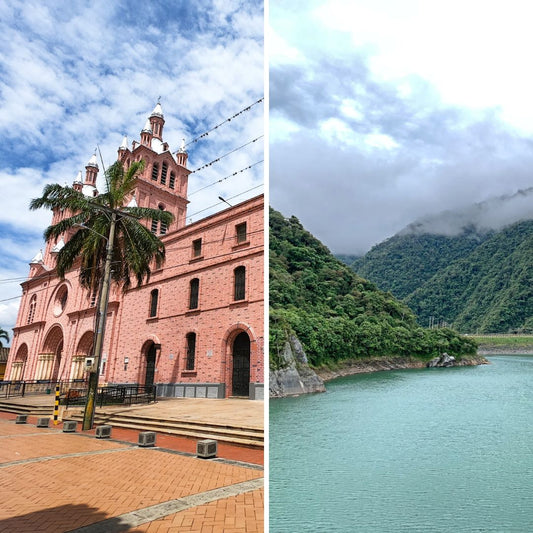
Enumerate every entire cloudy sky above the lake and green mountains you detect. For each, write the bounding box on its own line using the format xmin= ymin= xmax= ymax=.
xmin=269 ymin=0 xmax=533 ymax=254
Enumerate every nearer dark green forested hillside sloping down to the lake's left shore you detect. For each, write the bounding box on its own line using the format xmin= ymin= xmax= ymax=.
xmin=269 ymin=209 xmax=476 ymax=368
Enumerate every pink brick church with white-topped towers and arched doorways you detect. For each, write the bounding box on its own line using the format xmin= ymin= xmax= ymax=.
xmin=5 ymin=103 xmax=264 ymax=399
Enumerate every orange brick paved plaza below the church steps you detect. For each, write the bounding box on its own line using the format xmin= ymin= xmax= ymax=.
xmin=0 ymin=415 xmax=264 ymax=533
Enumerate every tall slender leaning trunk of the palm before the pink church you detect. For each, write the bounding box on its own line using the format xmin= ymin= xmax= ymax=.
xmin=82 ymin=211 xmax=117 ymax=431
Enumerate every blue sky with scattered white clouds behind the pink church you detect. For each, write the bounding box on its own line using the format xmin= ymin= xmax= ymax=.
xmin=0 ymin=0 xmax=265 ymax=335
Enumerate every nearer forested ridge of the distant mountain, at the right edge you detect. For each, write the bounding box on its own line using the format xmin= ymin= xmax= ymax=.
xmin=403 ymin=220 xmax=533 ymax=333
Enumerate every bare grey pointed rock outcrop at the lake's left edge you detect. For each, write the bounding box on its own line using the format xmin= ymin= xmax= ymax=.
xmin=269 ymin=335 xmax=326 ymax=398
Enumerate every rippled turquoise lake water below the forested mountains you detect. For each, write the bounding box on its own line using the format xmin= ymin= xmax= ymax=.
xmin=269 ymin=355 xmax=533 ymax=533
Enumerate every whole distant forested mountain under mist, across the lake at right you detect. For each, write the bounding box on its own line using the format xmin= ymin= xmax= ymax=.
xmin=353 ymin=220 xmax=533 ymax=333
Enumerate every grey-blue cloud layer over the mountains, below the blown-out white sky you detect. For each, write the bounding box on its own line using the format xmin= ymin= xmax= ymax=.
xmin=270 ymin=2 xmax=533 ymax=254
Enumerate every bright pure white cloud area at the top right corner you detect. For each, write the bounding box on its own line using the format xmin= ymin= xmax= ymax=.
xmin=310 ymin=0 xmax=533 ymax=133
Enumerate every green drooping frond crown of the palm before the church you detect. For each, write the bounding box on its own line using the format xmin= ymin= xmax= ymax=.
xmin=30 ymin=161 xmax=174 ymax=292
